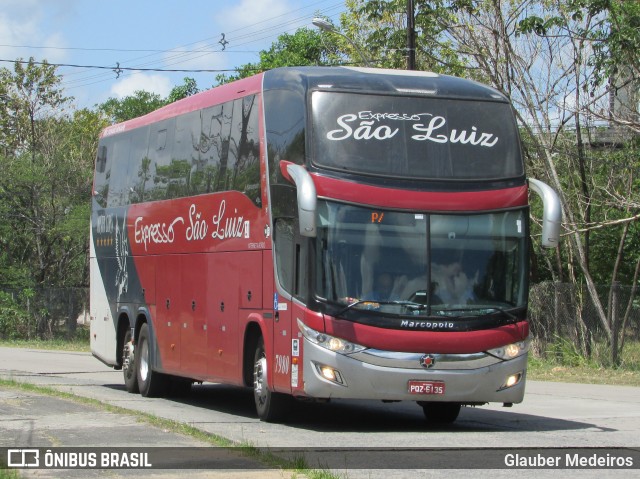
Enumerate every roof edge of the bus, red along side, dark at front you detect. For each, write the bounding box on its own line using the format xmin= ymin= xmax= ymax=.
xmin=100 ymin=66 xmax=508 ymax=138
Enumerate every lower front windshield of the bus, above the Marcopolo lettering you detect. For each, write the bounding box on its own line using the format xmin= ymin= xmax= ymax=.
xmin=315 ymin=201 xmax=527 ymax=316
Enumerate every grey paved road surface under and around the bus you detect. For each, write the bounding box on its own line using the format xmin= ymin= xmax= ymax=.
xmin=0 ymin=348 xmax=640 ymax=479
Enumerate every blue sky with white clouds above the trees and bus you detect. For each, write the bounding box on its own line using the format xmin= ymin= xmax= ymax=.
xmin=0 ymin=0 xmax=345 ymax=107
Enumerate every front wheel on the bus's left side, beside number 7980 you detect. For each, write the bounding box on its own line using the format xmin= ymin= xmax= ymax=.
xmin=253 ymin=337 xmax=291 ymax=422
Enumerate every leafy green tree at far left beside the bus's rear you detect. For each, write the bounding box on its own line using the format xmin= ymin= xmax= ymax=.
xmin=0 ymin=61 xmax=105 ymax=288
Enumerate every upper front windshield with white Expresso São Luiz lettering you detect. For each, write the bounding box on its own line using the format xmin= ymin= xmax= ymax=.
xmin=311 ymin=91 xmax=523 ymax=180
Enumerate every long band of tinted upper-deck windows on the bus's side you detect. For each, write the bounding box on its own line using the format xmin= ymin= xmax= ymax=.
xmin=95 ymin=96 xmax=262 ymax=206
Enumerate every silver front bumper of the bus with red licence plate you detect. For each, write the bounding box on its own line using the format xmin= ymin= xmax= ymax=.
xmin=303 ymin=338 xmax=527 ymax=404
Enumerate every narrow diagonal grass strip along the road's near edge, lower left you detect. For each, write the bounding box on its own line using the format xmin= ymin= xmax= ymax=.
xmin=0 ymin=379 xmax=342 ymax=479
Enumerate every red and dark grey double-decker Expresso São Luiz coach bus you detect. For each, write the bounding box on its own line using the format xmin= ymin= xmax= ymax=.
xmin=91 ymin=67 xmax=560 ymax=422
